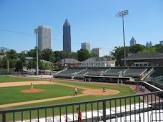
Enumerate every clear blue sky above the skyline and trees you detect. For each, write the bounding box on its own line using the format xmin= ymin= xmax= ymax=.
xmin=0 ymin=0 xmax=163 ymax=55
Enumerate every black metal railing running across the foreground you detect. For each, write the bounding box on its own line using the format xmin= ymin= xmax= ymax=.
xmin=0 ymin=91 xmax=163 ymax=122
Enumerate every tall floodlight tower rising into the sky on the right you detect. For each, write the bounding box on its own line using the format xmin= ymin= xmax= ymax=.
xmin=117 ymin=10 xmax=128 ymax=67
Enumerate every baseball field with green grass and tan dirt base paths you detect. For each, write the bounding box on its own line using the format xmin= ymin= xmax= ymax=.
xmin=0 ymin=76 xmax=136 ymax=109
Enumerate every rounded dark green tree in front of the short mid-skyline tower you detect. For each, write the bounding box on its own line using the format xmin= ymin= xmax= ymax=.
xmin=77 ymin=49 xmax=90 ymax=61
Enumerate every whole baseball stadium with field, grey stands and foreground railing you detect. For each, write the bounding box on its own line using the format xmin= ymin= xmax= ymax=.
xmin=0 ymin=67 xmax=163 ymax=122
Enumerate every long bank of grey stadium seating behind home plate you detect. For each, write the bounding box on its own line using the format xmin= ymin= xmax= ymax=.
xmin=54 ymin=68 xmax=147 ymax=79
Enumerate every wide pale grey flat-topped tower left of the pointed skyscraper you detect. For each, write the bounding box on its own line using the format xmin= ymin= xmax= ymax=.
xmin=35 ymin=25 xmax=51 ymax=50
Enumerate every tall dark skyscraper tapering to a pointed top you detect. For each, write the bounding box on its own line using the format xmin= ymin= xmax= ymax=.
xmin=63 ymin=19 xmax=71 ymax=52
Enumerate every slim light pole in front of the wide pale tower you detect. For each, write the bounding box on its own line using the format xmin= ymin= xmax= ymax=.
xmin=35 ymin=29 xmax=39 ymax=75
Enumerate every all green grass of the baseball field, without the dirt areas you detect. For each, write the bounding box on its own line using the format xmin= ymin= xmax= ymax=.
xmin=0 ymin=76 xmax=135 ymax=107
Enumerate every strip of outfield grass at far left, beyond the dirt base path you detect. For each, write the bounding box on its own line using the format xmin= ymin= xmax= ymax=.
xmin=0 ymin=75 xmax=39 ymax=83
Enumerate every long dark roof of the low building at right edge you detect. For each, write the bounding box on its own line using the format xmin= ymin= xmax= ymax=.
xmin=126 ymin=53 xmax=163 ymax=60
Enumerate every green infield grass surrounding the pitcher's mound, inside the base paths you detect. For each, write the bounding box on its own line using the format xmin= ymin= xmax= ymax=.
xmin=0 ymin=85 xmax=74 ymax=104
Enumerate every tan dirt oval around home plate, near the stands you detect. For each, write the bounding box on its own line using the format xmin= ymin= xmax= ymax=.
xmin=82 ymin=89 xmax=119 ymax=95
